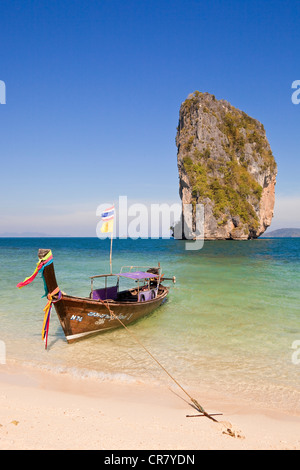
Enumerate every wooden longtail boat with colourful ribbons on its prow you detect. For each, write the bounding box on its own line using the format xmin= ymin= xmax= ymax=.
xmin=17 ymin=249 xmax=175 ymax=348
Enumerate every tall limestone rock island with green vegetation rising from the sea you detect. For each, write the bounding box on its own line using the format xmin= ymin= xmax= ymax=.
xmin=176 ymin=91 xmax=277 ymax=239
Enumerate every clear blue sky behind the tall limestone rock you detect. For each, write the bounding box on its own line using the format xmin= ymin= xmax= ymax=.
xmin=0 ymin=0 xmax=300 ymax=236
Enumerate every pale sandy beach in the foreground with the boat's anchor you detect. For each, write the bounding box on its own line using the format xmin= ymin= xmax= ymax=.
xmin=0 ymin=365 xmax=300 ymax=450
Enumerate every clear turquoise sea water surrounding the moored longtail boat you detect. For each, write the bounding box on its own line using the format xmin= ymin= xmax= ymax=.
xmin=0 ymin=238 xmax=300 ymax=413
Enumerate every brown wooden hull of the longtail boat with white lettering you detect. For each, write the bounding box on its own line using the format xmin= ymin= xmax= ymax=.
xmin=54 ymin=286 xmax=168 ymax=343
